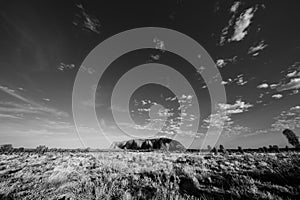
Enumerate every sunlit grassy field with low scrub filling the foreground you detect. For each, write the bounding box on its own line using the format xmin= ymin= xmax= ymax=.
xmin=0 ymin=152 xmax=300 ymax=200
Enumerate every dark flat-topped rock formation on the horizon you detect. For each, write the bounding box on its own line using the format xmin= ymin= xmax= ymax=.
xmin=110 ymin=138 xmax=185 ymax=151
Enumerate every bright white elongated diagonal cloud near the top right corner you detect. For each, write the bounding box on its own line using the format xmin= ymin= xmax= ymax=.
xmin=230 ymin=8 xmax=255 ymax=41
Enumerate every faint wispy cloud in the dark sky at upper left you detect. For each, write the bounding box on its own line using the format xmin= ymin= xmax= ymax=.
xmin=73 ymin=4 xmax=101 ymax=34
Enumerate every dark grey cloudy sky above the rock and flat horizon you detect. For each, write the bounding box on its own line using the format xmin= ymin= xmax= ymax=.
xmin=0 ymin=0 xmax=300 ymax=148
